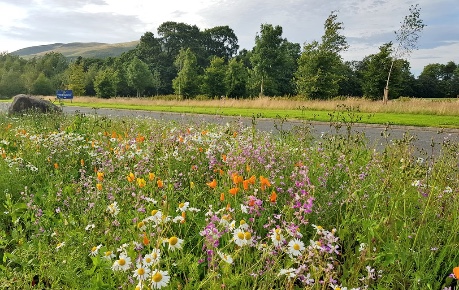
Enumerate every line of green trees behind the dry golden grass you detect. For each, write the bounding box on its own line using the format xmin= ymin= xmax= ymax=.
xmin=0 ymin=11 xmax=459 ymax=100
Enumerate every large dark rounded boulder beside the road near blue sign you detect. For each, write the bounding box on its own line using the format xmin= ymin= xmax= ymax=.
xmin=8 ymin=94 xmax=62 ymax=115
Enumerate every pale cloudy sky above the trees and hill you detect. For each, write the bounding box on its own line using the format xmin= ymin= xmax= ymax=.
xmin=0 ymin=0 xmax=459 ymax=76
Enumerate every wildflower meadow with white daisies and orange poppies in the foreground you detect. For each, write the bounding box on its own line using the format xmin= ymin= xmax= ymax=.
xmin=0 ymin=113 xmax=459 ymax=290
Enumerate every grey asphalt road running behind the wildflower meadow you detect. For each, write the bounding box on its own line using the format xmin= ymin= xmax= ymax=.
xmin=0 ymin=103 xmax=459 ymax=156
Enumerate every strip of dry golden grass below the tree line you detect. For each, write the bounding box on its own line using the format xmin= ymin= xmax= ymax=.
xmin=66 ymin=97 xmax=459 ymax=115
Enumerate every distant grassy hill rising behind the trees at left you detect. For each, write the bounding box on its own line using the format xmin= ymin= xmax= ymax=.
xmin=11 ymin=41 xmax=139 ymax=58
